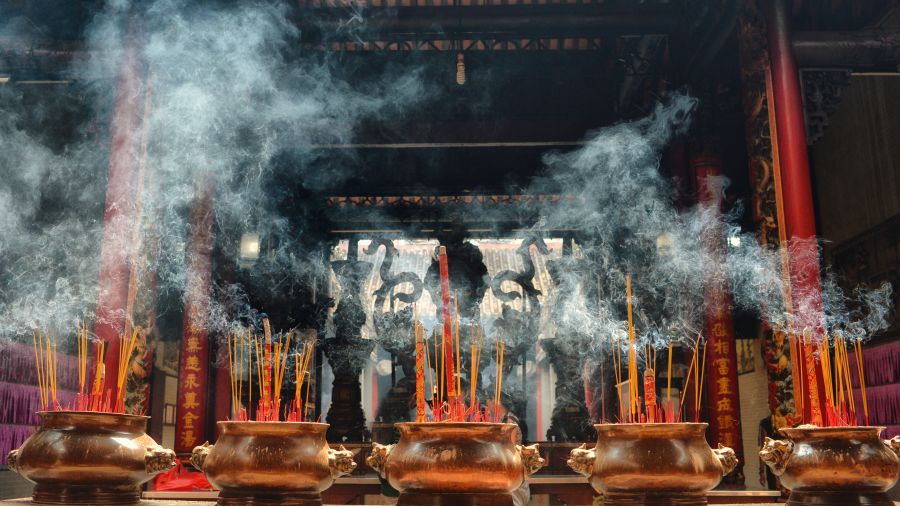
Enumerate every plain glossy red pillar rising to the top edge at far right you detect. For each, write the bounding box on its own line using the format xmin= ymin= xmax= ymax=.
xmin=764 ymin=0 xmax=825 ymax=425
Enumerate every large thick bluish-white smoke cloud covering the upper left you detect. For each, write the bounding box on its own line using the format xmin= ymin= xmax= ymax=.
xmin=0 ymin=0 xmax=424 ymax=339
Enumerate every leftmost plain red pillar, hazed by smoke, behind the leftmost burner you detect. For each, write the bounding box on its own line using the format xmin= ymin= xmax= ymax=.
xmin=94 ymin=38 xmax=147 ymax=398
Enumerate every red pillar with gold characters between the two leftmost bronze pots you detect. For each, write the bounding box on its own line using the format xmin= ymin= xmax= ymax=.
xmin=175 ymin=184 xmax=213 ymax=452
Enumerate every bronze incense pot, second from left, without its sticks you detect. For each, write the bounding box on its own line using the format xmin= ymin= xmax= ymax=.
xmin=191 ymin=421 xmax=356 ymax=506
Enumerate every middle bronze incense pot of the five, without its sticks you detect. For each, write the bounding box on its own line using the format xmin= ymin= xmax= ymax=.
xmin=366 ymin=422 xmax=544 ymax=506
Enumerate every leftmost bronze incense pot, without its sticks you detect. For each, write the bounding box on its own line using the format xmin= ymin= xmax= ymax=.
xmin=7 ymin=411 xmax=176 ymax=505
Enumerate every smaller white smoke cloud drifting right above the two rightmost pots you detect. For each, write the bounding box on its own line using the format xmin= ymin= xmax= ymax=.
xmin=529 ymin=94 xmax=892 ymax=351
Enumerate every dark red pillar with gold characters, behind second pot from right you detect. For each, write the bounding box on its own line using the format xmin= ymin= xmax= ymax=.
xmin=691 ymin=154 xmax=744 ymax=484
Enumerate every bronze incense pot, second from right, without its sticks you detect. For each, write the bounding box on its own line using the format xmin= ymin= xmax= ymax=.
xmin=567 ymin=423 xmax=738 ymax=506
